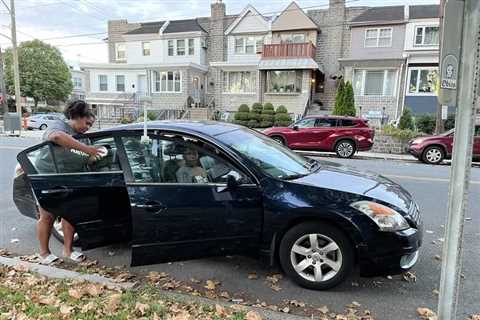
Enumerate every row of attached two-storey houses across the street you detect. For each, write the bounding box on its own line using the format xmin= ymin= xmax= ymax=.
xmin=82 ymin=0 xmax=444 ymax=124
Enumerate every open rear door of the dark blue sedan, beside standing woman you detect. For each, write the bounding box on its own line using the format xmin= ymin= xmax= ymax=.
xmin=17 ymin=134 xmax=131 ymax=249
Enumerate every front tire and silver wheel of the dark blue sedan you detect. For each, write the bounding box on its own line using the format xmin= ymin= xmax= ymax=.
xmin=279 ymin=222 xmax=355 ymax=290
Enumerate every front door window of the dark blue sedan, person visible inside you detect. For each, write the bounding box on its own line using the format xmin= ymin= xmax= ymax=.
xmin=122 ymin=136 xmax=250 ymax=184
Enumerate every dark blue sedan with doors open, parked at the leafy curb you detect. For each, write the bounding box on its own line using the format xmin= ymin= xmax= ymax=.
xmin=13 ymin=122 xmax=422 ymax=289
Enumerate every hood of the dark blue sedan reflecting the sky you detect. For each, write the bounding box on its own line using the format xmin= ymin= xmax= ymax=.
xmin=294 ymin=162 xmax=412 ymax=213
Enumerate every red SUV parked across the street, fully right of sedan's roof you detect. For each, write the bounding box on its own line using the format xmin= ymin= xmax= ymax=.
xmin=264 ymin=116 xmax=375 ymax=158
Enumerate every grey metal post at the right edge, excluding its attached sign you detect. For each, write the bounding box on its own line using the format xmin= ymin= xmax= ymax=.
xmin=438 ymin=0 xmax=480 ymax=320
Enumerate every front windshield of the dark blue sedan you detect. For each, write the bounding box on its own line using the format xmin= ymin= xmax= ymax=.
xmin=217 ymin=129 xmax=318 ymax=179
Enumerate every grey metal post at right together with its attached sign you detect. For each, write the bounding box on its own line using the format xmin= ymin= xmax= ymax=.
xmin=438 ymin=0 xmax=480 ymax=320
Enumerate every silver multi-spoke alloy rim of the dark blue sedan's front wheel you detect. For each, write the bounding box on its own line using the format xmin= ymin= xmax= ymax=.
xmin=290 ymin=234 xmax=343 ymax=282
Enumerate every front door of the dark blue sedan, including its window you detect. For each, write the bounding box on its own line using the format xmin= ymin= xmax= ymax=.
xmin=122 ymin=136 xmax=263 ymax=265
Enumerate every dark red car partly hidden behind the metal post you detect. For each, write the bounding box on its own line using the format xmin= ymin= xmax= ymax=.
xmin=408 ymin=125 xmax=480 ymax=164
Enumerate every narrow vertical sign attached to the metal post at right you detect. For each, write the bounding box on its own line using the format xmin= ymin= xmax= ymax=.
xmin=438 ymin=0 xmax=465 ymax=106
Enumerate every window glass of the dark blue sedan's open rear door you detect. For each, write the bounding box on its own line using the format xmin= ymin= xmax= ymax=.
xmin=27 ymin=137 xmax=121 ymax=174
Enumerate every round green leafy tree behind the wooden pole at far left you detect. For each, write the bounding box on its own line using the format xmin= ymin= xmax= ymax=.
xmin=5 ymin=40 xmax=73 ymax=109
